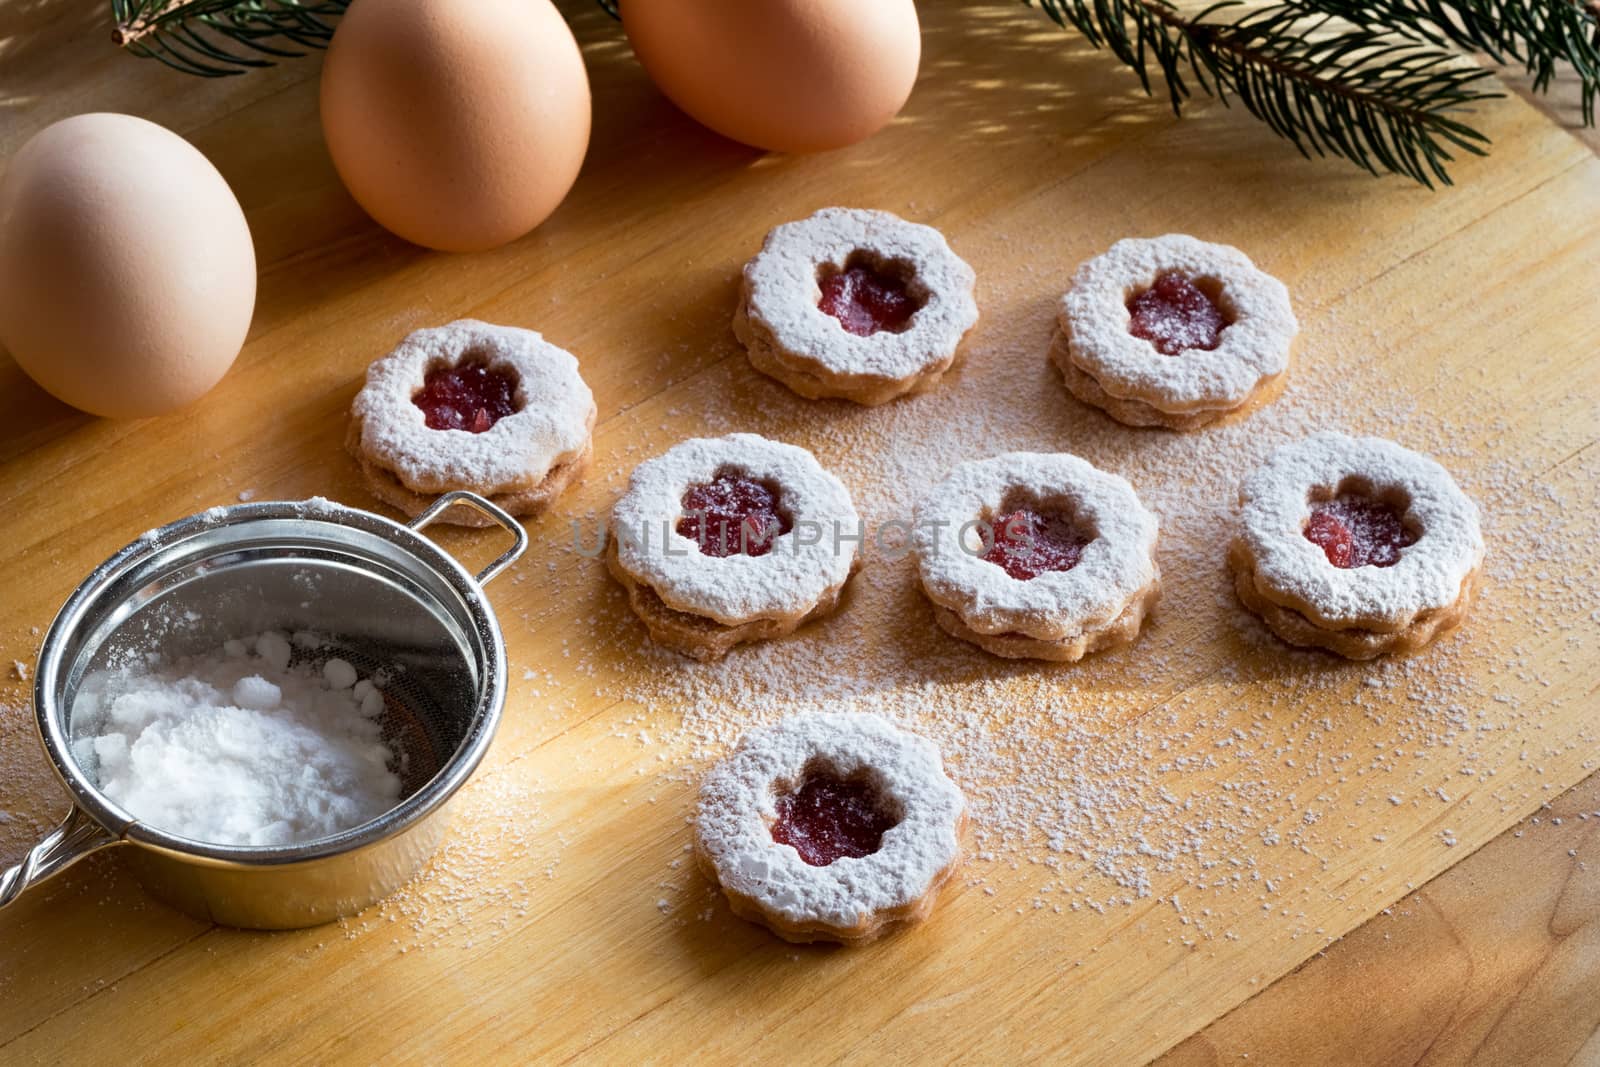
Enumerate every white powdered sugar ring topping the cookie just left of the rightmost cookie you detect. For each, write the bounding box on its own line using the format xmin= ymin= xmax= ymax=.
xmin=914 ymin=453 xmax=1157 ymax=641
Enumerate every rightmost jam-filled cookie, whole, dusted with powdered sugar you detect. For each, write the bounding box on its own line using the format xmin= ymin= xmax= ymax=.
xmin=1227 ymin=434 xmax=1483 ymax=659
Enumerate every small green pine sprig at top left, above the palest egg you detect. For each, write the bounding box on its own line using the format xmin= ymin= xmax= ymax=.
xmin=110 ymin=0 xmax=349 ymax=78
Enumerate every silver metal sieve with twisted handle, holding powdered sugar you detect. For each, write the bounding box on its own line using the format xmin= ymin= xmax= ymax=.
xmin=0 ymin=493 xmax=528 ymax=929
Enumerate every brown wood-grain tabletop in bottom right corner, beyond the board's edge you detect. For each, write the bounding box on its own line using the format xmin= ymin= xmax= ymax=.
xmin=1158 ymin=776 xmax=1600 ymax=1067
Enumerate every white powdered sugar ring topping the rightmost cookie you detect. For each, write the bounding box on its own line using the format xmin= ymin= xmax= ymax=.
xmin=1238 ymin=432 xmax=1483 ymax=627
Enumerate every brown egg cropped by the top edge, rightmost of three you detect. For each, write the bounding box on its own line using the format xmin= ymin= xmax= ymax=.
xmin=621 ymin=0 xmax=922 ymax=152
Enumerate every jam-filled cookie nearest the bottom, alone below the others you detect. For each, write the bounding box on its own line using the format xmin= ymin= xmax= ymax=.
xmin=694 ymin=713 xmax=966 ymax=944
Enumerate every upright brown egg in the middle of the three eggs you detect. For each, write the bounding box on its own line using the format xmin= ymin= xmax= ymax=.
xmin=322 ymin=0 xmax=589 ymax=251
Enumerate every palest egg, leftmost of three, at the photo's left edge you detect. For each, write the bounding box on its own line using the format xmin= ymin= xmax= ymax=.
xmin=0 ymin=114 xmax=256 ymax=418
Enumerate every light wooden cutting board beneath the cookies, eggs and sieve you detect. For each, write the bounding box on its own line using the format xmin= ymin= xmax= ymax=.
xmin=0 ymin=0 xmax=1600 ymax=1062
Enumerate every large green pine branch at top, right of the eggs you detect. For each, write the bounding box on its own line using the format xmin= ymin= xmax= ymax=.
xmin=1027 ymin=0 xmax=1499 ymax=187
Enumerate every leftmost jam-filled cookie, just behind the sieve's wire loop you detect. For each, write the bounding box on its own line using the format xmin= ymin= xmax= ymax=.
xmin=346 ymin=318 xmax=595 ymax=526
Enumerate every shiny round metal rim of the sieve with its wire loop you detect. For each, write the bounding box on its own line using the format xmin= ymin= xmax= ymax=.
xmin=26 ymin=491 xmax=528 ymax=870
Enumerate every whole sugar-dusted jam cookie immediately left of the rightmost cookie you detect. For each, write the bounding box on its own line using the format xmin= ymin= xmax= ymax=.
xmin=912 ymin=453 xmax=1160 ymax=662
